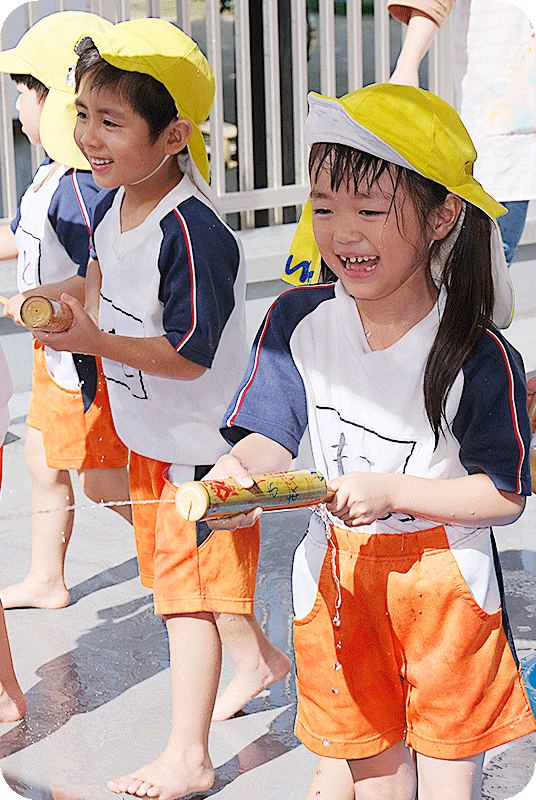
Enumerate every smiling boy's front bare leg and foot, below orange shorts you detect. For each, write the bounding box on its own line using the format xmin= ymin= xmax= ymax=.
xmin=108 ymin=612 xmax=221 ymax=800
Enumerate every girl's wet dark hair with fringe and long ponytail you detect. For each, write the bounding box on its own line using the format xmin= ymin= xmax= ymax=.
xmin=309 ymin=143 xmax=494 ymax=447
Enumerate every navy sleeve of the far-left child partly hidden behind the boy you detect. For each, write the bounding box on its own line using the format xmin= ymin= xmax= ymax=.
xmin=48 ymin=170 xmax=99 ymax=269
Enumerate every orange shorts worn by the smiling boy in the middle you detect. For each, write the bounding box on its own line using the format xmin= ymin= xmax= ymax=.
xmin=129 ymin=453 xmax=260 ymax=615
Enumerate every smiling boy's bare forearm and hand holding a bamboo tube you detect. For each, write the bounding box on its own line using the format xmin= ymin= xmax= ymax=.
xmin=33 ymin=294 xmax=206 ymax=380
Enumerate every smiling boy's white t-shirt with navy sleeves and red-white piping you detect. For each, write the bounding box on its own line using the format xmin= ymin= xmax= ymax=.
xmin=93 ymin=175 xmax=247 ymax=465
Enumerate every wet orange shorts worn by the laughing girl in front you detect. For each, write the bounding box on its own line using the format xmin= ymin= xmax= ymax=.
xmin=294 ymin=527 xmax=536 ymax=759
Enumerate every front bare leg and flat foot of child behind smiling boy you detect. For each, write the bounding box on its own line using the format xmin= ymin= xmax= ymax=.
xmin=0 ymin=427 xmax=74 ymax=608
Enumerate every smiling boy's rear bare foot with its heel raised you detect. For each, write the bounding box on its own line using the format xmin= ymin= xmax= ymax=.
xmin=212 ymin=648 xmax=292 ymax=722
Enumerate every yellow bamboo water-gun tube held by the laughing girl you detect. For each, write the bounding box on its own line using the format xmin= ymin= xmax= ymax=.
xmin=175 ymin=469 xmax=333 ymax=522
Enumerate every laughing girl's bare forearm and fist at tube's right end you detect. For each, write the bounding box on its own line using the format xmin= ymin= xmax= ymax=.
xmin=328 ymin=472 xmax=525 ymax=528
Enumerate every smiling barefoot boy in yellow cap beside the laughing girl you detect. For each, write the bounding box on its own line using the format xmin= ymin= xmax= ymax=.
xmin=37 ymin=18 xmax=290 ymax=800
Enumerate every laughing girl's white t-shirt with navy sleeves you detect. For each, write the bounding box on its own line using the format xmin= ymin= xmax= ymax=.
xmin=222 ymin=282 xmax=531 ymax=610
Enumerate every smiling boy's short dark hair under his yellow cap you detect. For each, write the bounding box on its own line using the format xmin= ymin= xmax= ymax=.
xmin=75 ymin=37 xmax=177 ymax=144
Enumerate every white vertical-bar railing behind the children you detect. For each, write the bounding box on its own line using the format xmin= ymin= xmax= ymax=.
xmin=0 ymin=0 xmax=452 ymax=227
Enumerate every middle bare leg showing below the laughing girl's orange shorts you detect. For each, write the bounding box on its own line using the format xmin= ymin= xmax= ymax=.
xmin=348 ymin=741 xmax=422 ymax=800
